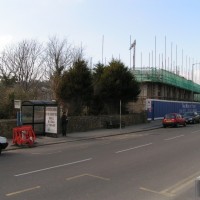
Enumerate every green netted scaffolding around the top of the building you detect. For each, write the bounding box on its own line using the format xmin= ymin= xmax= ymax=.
xmin=134 ymin=67 xmax=200 ymax=94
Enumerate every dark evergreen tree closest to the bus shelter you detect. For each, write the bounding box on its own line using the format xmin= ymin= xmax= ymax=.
xmin=57 ymin=58 xmax=93 ymax=115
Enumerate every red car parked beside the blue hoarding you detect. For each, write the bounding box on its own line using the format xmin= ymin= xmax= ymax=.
xmin=162 ymin=113 xmax=186 ymax=128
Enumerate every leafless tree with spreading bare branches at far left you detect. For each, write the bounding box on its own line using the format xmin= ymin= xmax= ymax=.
xmin=0 ymin=40 xmax=44 ymax=91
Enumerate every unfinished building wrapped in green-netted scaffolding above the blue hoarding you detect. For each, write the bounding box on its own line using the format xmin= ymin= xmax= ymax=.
xmin=129 ymin=68 xmax=200 ymax=112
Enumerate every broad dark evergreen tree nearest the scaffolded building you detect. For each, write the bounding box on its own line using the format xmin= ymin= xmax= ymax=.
xmin=95 ymin=59 xmax=140 ymax=112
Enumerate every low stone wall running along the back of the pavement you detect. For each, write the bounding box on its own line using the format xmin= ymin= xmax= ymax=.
xmin=0 ymin=112 xmax=147 ymax=138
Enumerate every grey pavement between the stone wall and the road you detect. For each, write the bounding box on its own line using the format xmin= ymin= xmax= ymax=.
xmin=4 ymin=120 xmax=162 ymax=151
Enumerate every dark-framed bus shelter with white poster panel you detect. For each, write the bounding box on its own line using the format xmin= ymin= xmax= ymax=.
xmin=21 ymin=100 xmax=60 ymax=137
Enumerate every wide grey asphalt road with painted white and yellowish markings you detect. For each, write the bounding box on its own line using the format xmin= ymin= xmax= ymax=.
xmin=0 ymin=124 xmax=200 ymax=200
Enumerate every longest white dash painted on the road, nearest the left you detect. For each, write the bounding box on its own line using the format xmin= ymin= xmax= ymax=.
xmin=14 ymin=158 xmax=92 ymax=177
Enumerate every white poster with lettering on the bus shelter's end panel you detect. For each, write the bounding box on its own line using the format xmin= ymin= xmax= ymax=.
xmin=45 ymin=107 xmax=58 ymax=133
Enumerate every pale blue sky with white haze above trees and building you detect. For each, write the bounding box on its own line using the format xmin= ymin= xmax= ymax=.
xmin=0 ymin=0 xmax=200 ymax=78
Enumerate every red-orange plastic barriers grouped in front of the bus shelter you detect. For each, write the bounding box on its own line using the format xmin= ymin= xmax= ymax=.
xmin=13 ymin=125 xmax=36 ymax=146
